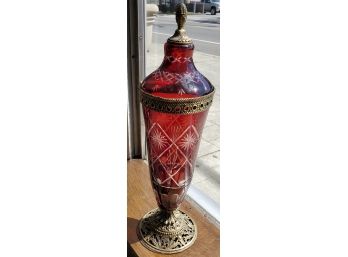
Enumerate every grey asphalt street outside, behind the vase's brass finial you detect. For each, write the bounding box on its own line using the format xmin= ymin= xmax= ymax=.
xmin=153 ymin=14 xmax=220 ymax=56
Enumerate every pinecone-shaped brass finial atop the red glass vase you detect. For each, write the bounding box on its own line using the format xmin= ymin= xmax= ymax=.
xmin=167 ymin=3 xmax=192 ymax=45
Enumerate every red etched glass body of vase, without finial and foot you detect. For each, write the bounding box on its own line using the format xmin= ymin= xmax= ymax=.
xmin=141 ymin=42 xmax=214 ymax=212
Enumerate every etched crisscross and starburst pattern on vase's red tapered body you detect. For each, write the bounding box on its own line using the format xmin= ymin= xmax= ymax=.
xmin=145 ymin=115 xmax=204 ymax=193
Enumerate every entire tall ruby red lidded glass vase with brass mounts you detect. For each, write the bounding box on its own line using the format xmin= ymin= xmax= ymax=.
xmin=138 ymin=4 xmax=214 ymax=253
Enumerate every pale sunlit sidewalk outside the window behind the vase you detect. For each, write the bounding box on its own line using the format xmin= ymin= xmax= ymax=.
xmin=146 ymin=43 xmax=220 ymax=204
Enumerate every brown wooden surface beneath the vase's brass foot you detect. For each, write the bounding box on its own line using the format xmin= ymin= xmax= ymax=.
xmin=127 ymin=160 xmax=220 ymax=257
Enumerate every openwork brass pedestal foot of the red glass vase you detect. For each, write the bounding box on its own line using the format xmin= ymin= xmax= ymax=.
xmin=137 ymin=209 xmax=197 ymax=254
